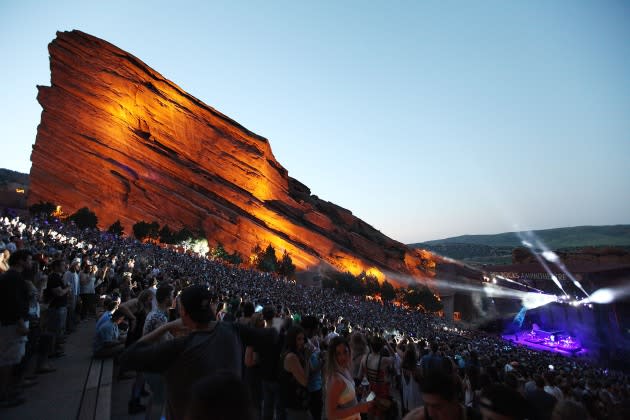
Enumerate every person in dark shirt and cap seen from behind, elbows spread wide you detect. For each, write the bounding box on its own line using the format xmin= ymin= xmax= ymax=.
xmin=121 ymin=286 xmax=277 ymax=419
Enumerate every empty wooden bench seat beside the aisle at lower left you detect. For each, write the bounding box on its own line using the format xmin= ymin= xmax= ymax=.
xmin=78 ymin=358 xmax=114 ymax=420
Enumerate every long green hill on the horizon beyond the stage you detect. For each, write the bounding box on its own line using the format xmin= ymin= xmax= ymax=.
xmin=409 ymin=225 xmax=630 ymax=265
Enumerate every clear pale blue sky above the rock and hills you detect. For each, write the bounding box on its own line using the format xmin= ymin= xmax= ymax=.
xmin=0 ymin=0 xmax=630 ymax=243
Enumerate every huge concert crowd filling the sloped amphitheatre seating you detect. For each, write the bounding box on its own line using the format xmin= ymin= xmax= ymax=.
xmin=0 ymin=218 xmax=630 ymax=420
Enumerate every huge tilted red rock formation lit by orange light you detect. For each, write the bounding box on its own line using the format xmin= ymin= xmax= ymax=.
xmin=29 ymin=31 xmax=434 ymax=284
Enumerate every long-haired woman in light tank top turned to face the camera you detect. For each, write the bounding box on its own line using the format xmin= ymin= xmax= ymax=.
xmin=326 ymin=336 xmax=373 ymax=420
